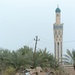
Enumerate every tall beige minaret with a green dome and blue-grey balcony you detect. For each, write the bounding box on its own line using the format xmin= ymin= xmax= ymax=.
xmin=53 ymin=7 xmax=63 ymax=63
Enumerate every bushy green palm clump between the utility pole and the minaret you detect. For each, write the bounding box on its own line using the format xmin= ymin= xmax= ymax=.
xmin=29 ymin=49 xmax=59 ymax=69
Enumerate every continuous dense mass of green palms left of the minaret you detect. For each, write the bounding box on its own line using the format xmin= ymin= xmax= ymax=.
xmin=0 ymin=46 xmax=59 ymax=75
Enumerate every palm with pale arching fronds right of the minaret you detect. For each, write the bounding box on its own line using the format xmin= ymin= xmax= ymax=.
xmin=64 ymin=50 xmax=75 ymax=70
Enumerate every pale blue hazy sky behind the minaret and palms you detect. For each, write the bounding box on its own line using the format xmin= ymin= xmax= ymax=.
xmin=0 ymin=0 xmax=75 ymax=52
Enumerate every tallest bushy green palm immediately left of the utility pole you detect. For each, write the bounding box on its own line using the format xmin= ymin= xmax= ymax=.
xmin=17 ymin=46 xmax=33 ymax=68
